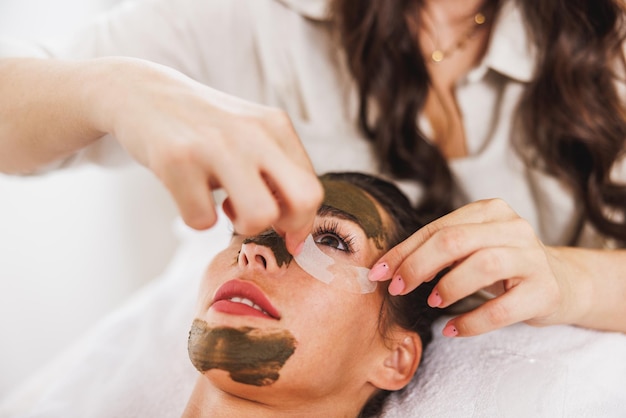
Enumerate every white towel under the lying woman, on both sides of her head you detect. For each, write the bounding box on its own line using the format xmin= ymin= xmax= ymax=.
xmin=0 ymin=216 xmax=626 ymax=418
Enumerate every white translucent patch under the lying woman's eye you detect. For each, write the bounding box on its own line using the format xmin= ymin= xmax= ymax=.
xmin=293 ymin=234 xmax=376 ymax=294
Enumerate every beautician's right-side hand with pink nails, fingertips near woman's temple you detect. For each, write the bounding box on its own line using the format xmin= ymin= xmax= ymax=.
xmin=370 ymin=199 xmax=597 ymax=336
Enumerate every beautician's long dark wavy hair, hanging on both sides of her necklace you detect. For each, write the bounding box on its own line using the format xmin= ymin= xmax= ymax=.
xmin=332 ymin=0 xmax=626 ymax=243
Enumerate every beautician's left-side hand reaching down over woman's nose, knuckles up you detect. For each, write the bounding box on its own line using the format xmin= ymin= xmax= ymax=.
xmin=93 ymin=55 xmax=323 ymax=253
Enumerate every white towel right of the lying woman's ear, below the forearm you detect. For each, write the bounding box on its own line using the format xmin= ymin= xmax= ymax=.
xmin=383 ymin=319 xmax=626 ymax=418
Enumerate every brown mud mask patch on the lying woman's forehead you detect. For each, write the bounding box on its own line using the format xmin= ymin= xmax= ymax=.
xmin=321 ymin=178 xmax=385 ymax=248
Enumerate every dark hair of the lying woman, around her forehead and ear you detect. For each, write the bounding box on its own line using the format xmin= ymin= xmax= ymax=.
xmin=321 ymin=172 xmax=442 ymax=417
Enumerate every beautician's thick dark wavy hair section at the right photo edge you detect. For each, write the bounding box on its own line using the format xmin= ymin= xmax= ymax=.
xmin=520 ymin=0 xmax=626 ymax=244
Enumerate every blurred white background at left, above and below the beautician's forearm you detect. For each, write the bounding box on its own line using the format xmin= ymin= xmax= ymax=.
xmin=0 ymin=0 xmax=176 ymax=400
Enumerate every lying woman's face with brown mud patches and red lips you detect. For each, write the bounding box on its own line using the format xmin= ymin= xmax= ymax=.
xmin=189 ymin=181 xmax=389 ymax=404
